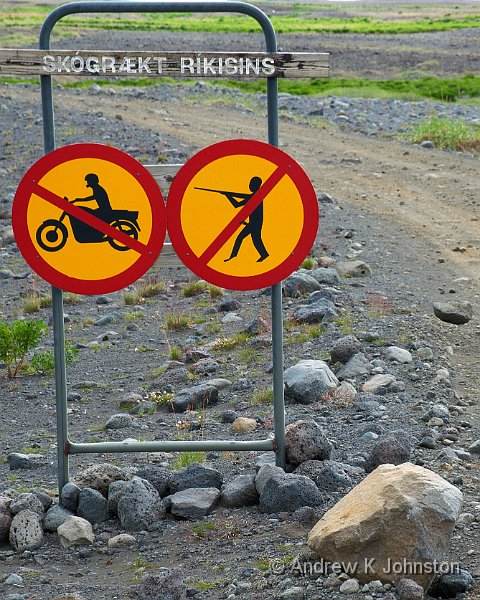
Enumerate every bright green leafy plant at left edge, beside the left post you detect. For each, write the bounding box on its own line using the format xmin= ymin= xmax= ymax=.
xmin=0 ymin=319 xmax=48 ymax=378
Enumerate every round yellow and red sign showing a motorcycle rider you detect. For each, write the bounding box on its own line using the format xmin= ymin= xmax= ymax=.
xmin=12 ymin=144 xmax=166 ymax=294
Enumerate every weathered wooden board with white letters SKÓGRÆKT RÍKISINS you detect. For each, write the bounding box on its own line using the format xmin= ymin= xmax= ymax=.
xmin=0 ymin=48 xmax=329 ymax=79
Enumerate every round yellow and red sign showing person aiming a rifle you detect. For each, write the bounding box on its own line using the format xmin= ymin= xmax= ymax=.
xmin=167 ymin=139 xmax=318 ymax=290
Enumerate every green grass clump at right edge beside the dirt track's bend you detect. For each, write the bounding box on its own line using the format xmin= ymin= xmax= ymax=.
xmin=411 ymin=117 xmax=480 ymax=152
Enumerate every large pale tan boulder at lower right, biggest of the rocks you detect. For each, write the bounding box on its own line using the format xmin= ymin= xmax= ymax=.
xmin=308 ymin=463 xmax=462 ymax=589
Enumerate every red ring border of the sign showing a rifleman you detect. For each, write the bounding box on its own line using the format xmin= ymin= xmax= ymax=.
xmin=167 ymin=139 xmax=319 ymax=291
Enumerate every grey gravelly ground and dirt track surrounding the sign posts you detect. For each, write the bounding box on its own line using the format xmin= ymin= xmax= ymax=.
xmin=0 ymin=3 xmax=480 ymax=600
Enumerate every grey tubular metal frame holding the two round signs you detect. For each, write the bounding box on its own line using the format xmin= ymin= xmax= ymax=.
xmin=39 ymin=0 xmax=285 ymax=491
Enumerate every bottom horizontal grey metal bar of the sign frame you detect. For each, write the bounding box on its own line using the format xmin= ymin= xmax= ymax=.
xmin=65 ymin=439 xmax=275 ymax=454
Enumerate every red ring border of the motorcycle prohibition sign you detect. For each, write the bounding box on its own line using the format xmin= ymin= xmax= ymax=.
xmin=12 ymin=143 xmax=167 ymax=295
